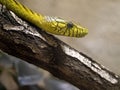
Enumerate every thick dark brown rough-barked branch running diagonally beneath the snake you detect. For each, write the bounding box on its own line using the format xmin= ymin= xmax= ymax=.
xmin=0 ymin=6 xmax=120 ymax=90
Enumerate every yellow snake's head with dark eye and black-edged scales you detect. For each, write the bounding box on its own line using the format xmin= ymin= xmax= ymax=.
xmin=42 ymin=16 xmax=88 ymax=37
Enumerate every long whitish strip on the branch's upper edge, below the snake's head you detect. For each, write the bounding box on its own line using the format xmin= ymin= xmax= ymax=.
xmin=61 ymin=45 xmax=118 ymax=84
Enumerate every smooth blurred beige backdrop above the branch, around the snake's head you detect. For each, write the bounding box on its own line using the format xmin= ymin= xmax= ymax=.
xmin=19 ymin=0 xmax=120 ymax=74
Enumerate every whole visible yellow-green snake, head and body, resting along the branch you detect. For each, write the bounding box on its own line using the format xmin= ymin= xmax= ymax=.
xmin=0 ymin=0 xmax=88 ymax=37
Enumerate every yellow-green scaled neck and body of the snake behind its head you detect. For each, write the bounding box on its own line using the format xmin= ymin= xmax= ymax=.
xmin=0 ymin=0 xmax=44 ymax=27
